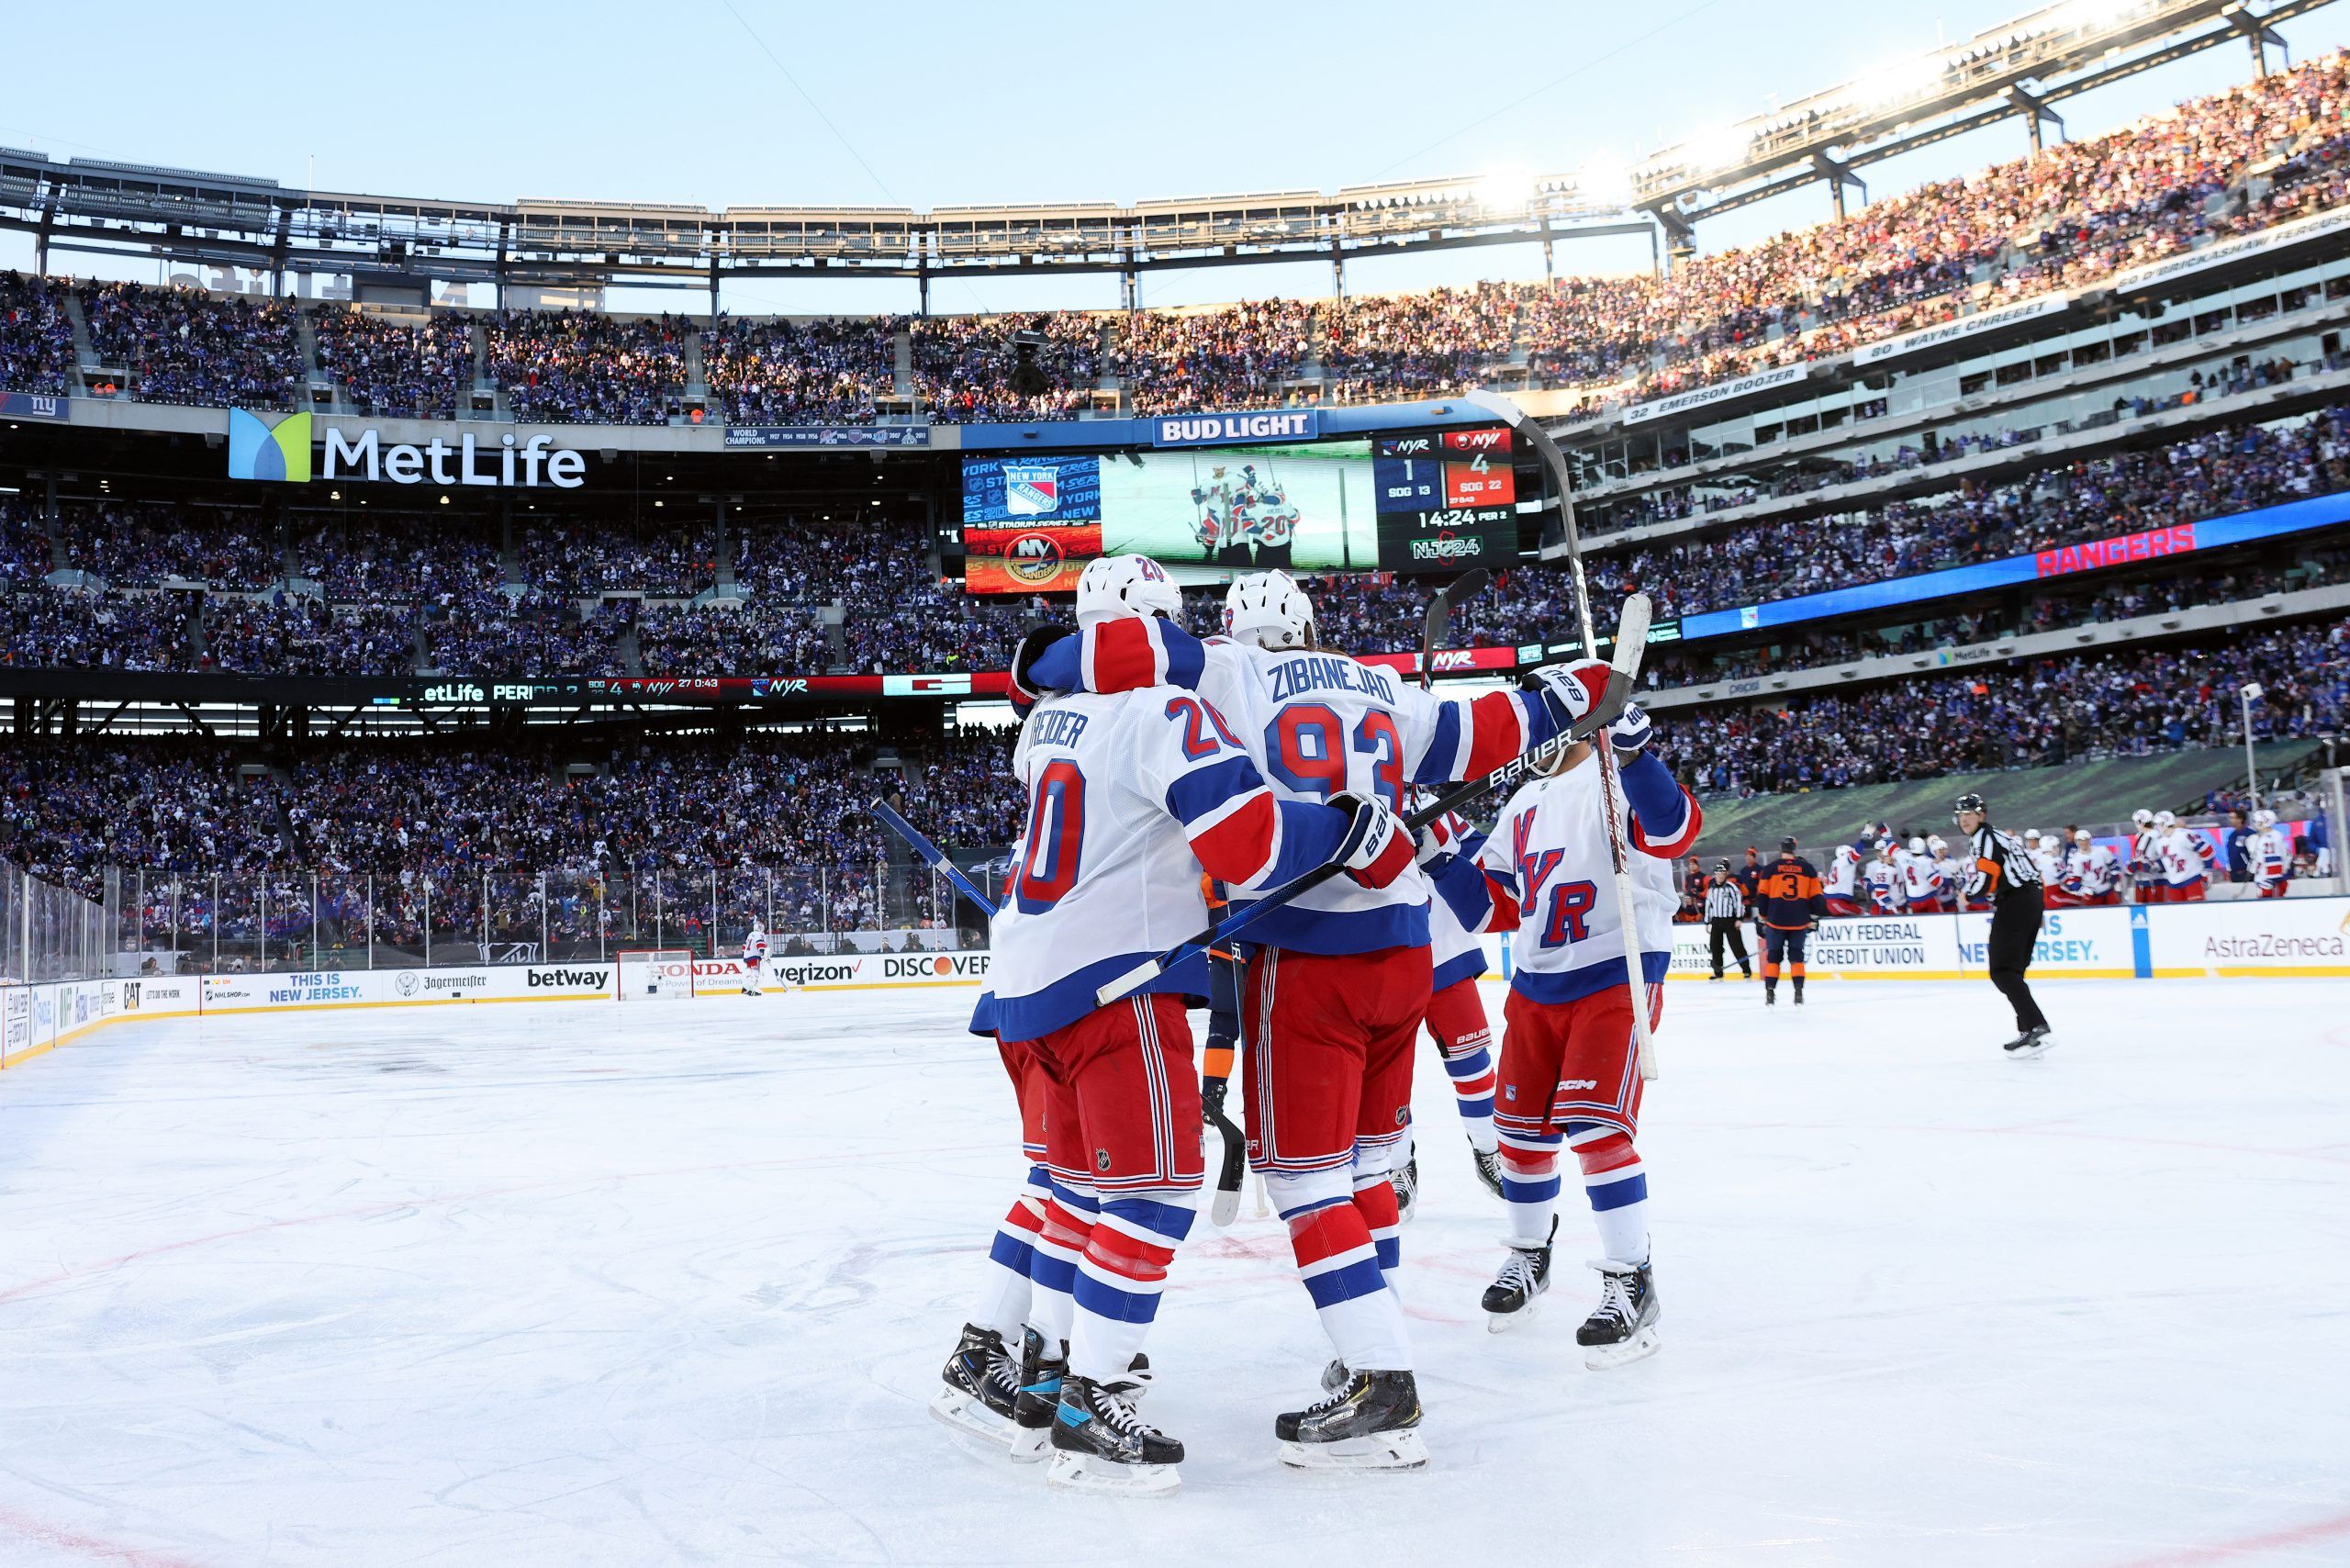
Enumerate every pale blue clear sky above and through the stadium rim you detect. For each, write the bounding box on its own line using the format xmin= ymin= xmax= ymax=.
xmin=0 ymin=0 xmax=2350 ymax=313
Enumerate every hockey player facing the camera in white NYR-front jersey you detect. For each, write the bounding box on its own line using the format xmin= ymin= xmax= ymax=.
xmin=1431 ymin=705 xmax=1701 ymax=1368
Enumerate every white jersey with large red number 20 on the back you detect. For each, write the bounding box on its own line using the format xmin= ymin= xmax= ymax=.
xmin=990 ymin=648 xmax=1347 ymax=1039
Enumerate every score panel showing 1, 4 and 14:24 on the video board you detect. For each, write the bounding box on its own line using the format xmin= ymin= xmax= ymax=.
xmin=1370 ymin=428 xmax=1518 ymax=571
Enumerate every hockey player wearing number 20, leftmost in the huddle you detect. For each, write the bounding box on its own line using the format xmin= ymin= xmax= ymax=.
xmin=991 ymin=554 xmax=1413 ymax=1493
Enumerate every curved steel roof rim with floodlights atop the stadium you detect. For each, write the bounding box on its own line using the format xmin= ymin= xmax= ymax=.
xmin=0 ymin=0 xmax=2329 ymax=310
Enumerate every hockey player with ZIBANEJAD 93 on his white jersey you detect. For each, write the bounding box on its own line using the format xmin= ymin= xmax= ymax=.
xmin=1039 ymin=571 xmax=1605 ymax=1469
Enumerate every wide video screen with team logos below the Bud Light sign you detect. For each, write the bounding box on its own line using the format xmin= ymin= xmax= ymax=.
xmin=964 ymin=428 xmax=1518 ymax=595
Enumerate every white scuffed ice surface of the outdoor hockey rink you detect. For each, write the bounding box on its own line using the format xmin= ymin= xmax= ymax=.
xmin=0 ymin=980 xmax=2350 ymax=1568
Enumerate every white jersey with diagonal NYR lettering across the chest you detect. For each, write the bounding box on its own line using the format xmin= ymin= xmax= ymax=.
xmin=1436 ymin=755 xmax=1704 ymax=1002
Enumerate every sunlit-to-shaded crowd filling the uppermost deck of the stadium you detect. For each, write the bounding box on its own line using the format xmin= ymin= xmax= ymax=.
xmin=0 ymin=54 xmax=2350 ymax=423
